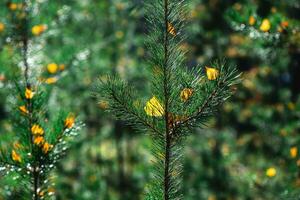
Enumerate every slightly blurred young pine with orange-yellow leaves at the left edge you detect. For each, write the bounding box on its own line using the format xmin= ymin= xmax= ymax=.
xmin=0 ymin=0 xmax=79 ymax=200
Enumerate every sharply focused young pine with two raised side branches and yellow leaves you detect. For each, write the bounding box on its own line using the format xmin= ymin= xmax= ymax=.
xmin=95 ymin=0 xmax=239 ymax=200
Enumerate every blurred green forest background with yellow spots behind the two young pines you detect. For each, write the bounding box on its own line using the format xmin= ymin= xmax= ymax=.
xmin=0 ymin=0 xmax=300 ymax=200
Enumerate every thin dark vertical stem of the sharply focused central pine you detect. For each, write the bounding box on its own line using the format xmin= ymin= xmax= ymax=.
xmin=163 ymin=0 xmax=171 ymax=200
